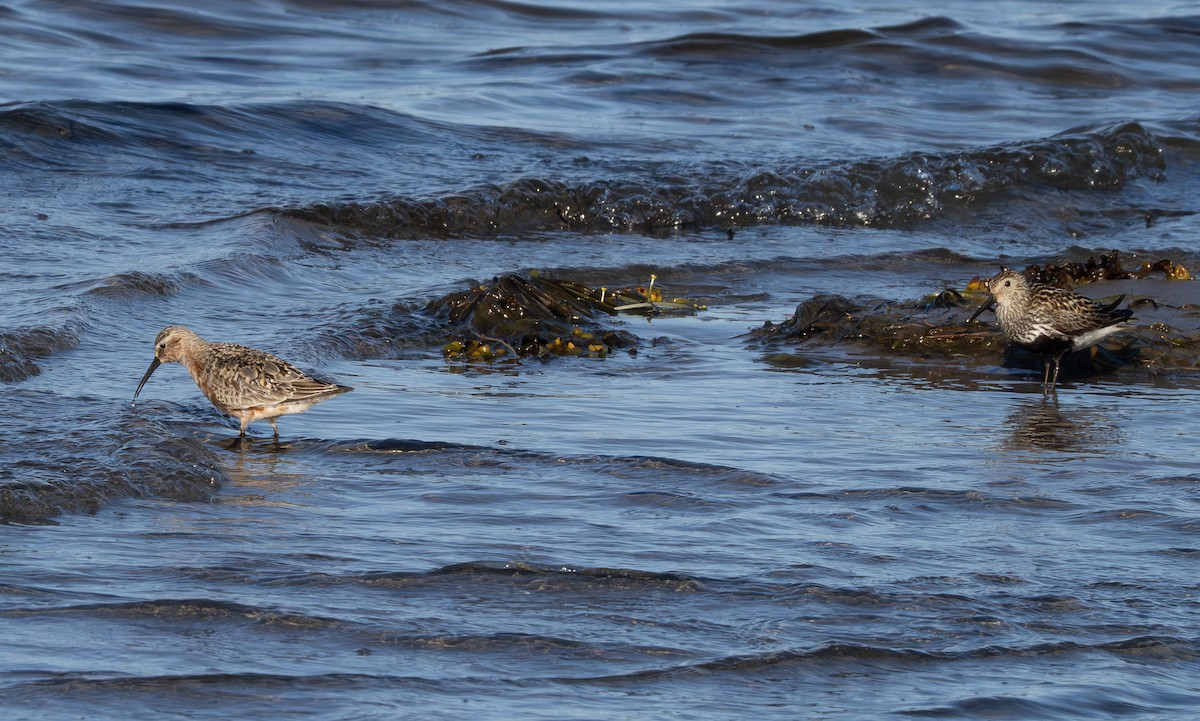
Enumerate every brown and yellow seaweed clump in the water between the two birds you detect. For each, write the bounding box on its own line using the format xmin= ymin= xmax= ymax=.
xmin=426 ymin=272 xmax=702 ymax=360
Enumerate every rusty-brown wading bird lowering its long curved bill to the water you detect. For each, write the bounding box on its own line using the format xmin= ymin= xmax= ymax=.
xmin=133 ymin=325 xmax=354 ymax=441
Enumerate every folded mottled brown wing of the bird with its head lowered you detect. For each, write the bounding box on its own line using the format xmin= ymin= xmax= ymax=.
xmin=204 ymin=343 xmax=349 ymax=409
